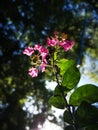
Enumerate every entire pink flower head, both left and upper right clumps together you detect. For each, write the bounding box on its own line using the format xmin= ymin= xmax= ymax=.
xmin=23 ymin=32 xmax=74 ymax=77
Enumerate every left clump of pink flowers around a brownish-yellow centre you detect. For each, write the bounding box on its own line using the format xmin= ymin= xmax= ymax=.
xmin=23 ymin=44 xmax=48 ymax=77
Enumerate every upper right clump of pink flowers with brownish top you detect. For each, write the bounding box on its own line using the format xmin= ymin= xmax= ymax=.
xmin=46 ymin=32 xmax=74 ymax=51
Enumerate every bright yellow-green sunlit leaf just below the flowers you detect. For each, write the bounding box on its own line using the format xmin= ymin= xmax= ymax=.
xmin=57 ymin=59 xmax=75 ymax=75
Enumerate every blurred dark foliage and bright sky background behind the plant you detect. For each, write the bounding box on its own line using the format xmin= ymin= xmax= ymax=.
xmin=0 ymin=0 xmax=98 ymax=130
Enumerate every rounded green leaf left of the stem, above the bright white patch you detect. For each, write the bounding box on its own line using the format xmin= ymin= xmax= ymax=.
xmin=49 ymin=96 xmax=66 ymax=109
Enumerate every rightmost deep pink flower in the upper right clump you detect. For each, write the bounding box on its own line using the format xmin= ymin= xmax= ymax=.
xmin=59 ymin=40 xmax=74 ymax=51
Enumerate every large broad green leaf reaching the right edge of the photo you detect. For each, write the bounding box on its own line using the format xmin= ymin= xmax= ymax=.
xmin=69 ymin=84 xmax=98 ymax=106
